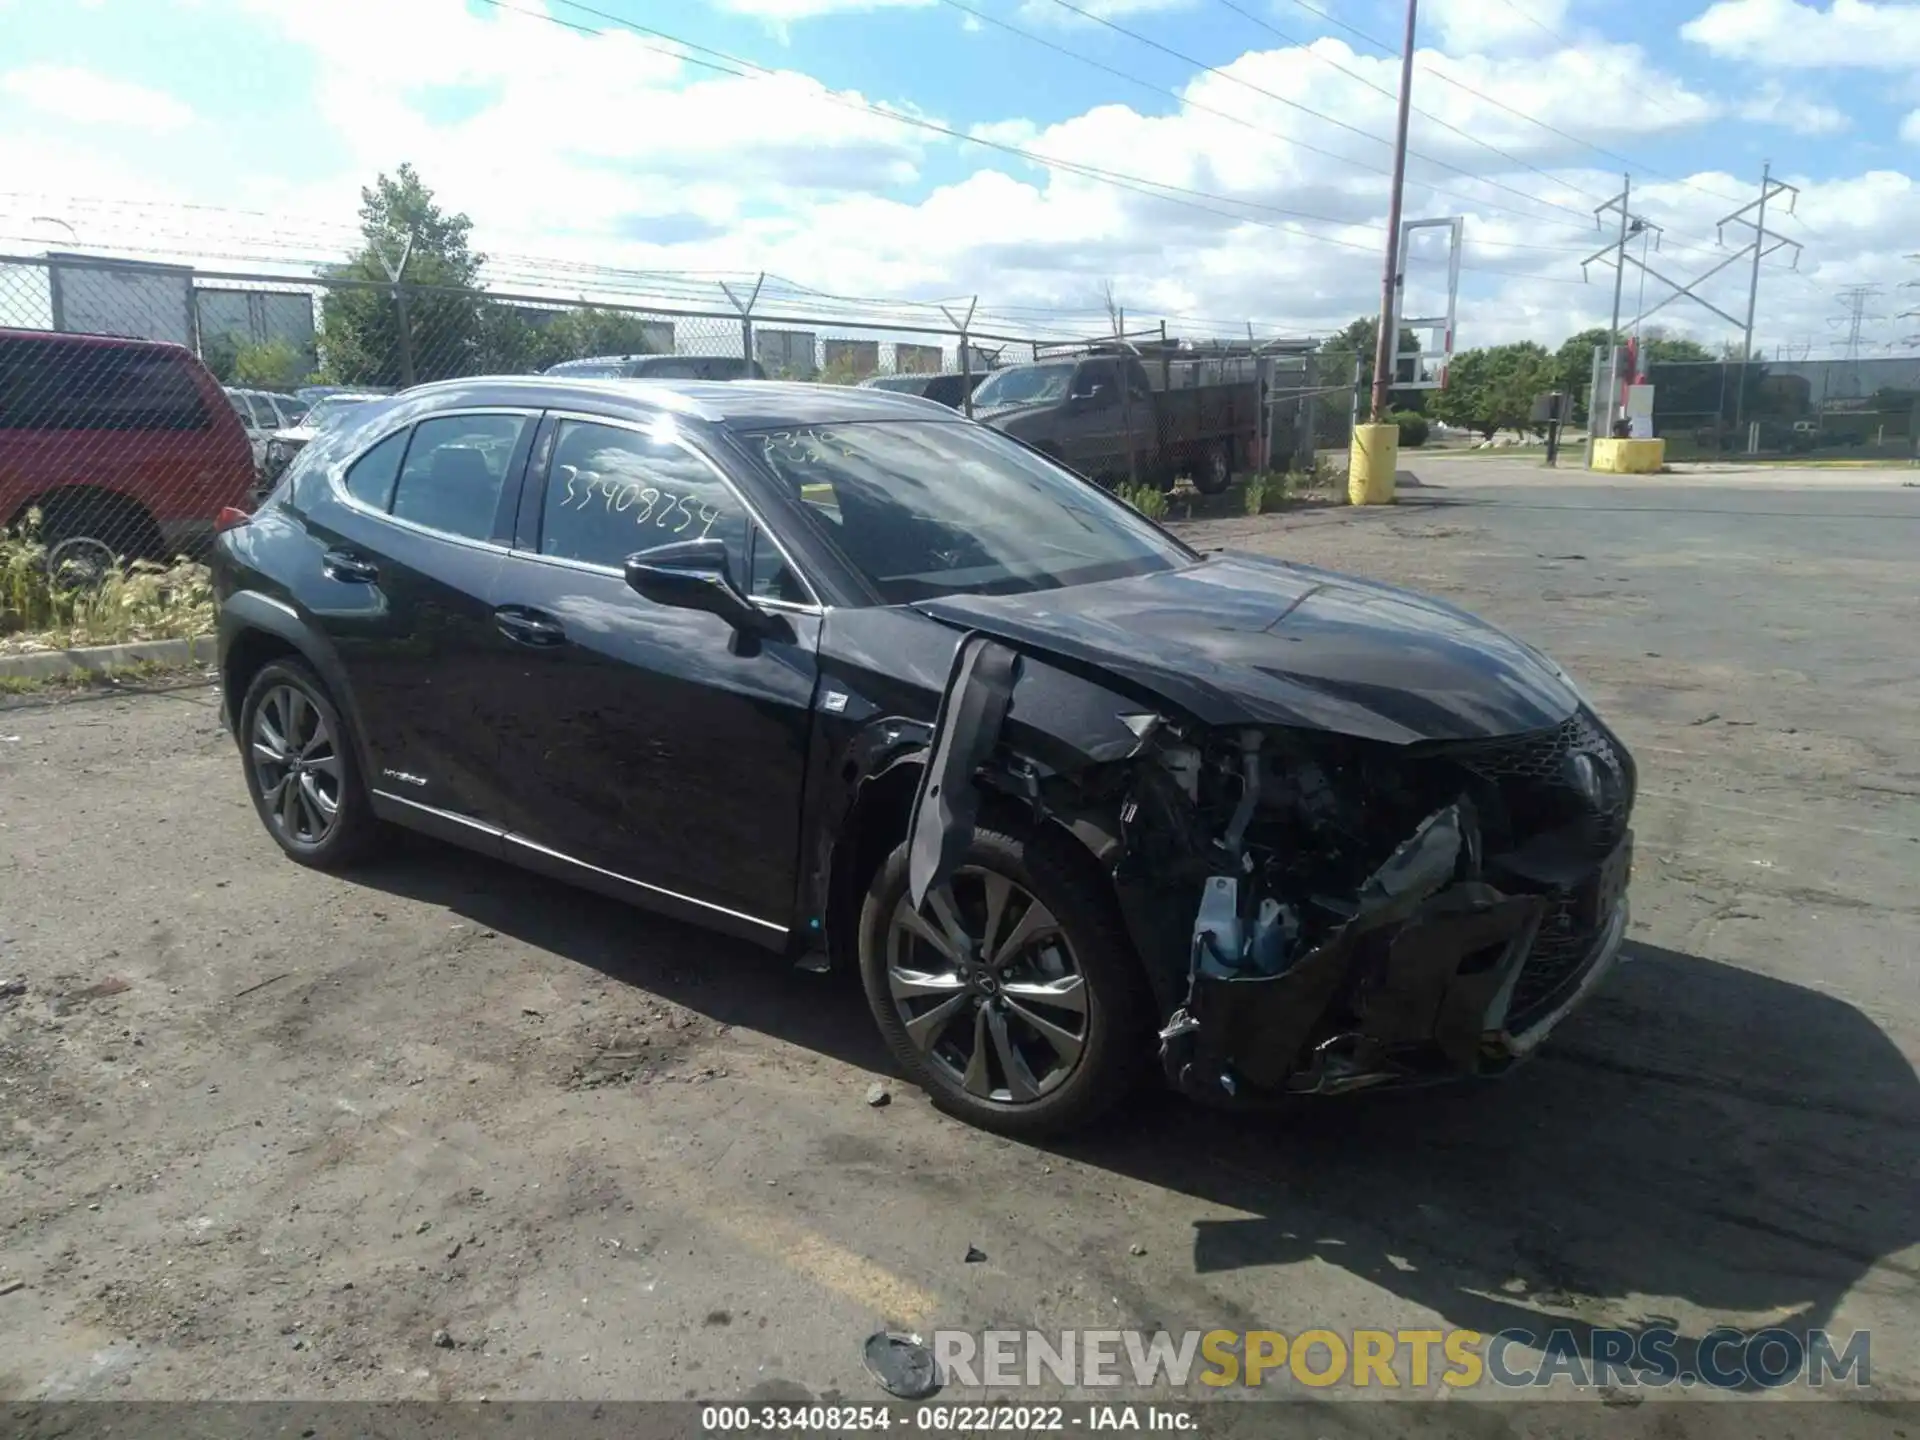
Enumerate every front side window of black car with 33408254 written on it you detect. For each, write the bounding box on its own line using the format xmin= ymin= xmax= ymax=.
xmin=541 ymin=420 xmax=747 ymax=576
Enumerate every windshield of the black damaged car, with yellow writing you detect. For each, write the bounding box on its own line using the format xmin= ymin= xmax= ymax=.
xmin=741 ymin=416 xmax=1194 ymax=605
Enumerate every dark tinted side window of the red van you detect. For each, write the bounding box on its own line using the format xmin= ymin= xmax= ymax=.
xmin=0 ymin=338 xmax=213 ymax=430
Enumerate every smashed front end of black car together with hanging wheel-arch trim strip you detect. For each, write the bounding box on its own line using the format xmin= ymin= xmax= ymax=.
xmin=910 ymin=634 xmax=1636 ymax=1098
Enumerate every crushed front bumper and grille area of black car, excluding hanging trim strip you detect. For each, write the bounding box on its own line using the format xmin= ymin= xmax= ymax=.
xmin=1117 ymin=710 xmax=1634 ymax=1096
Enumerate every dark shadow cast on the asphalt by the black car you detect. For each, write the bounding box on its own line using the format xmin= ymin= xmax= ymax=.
xmin=357 ymin=837 xmax=1920 ymax=1373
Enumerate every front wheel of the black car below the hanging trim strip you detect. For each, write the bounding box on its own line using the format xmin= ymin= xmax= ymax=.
xmin=860 ymin=828 xmax=1150 ymax=1139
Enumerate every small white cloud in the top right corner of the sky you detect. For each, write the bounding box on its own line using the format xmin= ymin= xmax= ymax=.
xmin=1680 ymin=0 xmax=1920 ymax=69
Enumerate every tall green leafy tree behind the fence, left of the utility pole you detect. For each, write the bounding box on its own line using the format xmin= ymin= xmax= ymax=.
xmin=321 ymin=165 xmax=490 ymax=386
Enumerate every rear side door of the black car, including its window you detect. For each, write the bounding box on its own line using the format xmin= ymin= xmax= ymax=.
xmin=303 ymin=409 xmax=538 ymax=824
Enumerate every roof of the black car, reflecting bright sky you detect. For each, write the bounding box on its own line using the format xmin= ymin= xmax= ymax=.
xmin=394 ymin=374 xmax=954 ymax=430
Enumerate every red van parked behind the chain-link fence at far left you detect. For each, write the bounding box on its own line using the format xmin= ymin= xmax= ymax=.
xmin=0 ymin=330 xmax=253 ymax=559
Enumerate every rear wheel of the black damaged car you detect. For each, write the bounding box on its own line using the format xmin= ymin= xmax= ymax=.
xmin=238 ymin=659 xmax=382 ymax=870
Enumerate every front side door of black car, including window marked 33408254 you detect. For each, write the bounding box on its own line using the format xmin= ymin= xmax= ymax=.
xmin=493 ymin=417 xmax=820 ymax=945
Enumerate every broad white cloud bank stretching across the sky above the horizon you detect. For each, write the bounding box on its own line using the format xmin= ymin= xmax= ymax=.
xmin=0 ymin=0 xmax=1920 ymax=360
